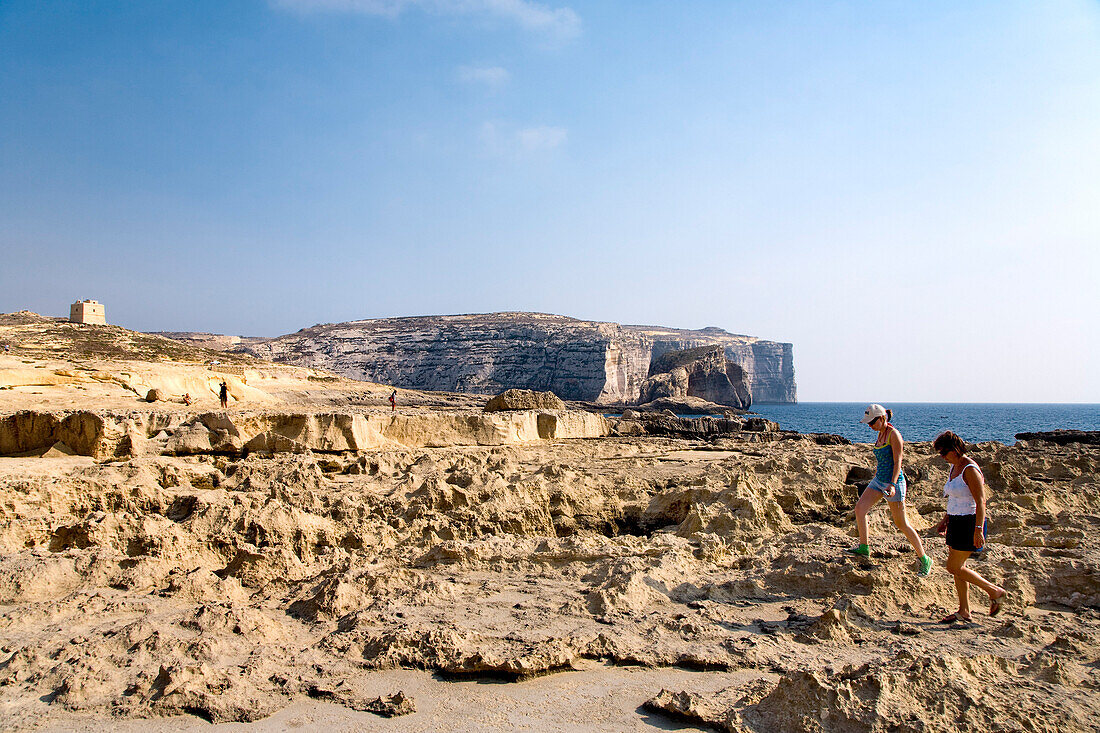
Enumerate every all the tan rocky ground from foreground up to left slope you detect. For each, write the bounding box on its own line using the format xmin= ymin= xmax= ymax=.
xmin=0 ymin=310 xmax=1100 ymax=733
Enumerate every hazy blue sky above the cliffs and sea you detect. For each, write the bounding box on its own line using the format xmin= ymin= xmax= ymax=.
xmin=0 ymin=0 xmax=1100 ymax=402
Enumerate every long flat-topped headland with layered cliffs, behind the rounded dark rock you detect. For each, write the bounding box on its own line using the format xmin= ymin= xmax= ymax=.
xmin=223 ymin=313 xmax=798 ymax=403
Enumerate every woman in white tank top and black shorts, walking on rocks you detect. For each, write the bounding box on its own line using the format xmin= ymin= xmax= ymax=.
xmin=932 ymin=430 xmax=1007 ymax=624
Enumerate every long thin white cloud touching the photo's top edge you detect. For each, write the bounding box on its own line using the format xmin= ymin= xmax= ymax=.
xmin=270 ymin=0 xmax=581 ymax=39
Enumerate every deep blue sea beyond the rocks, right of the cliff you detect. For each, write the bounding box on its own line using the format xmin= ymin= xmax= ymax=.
xmin=751 ymin=402 xmax=1100 ymax=446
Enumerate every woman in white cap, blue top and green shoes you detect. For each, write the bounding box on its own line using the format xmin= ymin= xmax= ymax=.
xmin=848 ymin=405 xmax=932 ymax=578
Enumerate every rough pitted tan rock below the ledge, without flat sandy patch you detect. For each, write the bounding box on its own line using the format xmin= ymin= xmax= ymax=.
xmin=0 ymin=431 xmax=1100 ymax=731
